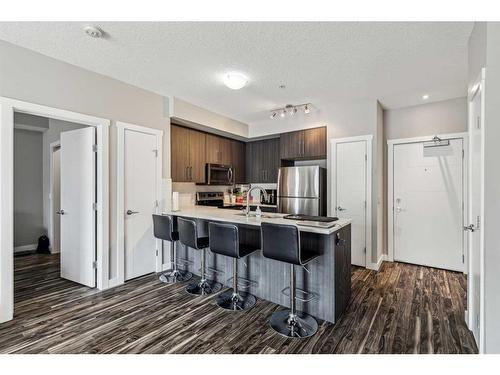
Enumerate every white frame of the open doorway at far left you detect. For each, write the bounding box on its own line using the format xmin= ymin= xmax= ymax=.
xmin=0 ymin=97 xmax=110 ymax=322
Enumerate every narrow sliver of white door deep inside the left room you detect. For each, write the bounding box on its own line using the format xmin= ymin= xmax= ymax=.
xmin=50 ymin=147 xmax=61 ymax=253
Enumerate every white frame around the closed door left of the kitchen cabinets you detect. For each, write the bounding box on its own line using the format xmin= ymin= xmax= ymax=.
xmin=116 ymin=121 xmax=164 ymax=286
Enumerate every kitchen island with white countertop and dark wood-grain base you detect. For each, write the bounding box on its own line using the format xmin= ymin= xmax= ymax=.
xmin=164 ymin=206 xmax=351 ymax=323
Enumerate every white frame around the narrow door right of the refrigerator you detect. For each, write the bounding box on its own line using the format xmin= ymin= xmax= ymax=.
xmin=330 ymin=134 xmax=379 ymax=270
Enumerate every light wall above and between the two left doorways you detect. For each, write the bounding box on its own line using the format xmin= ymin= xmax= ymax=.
xmin=0 ymin=41 xmax=170 ymax=284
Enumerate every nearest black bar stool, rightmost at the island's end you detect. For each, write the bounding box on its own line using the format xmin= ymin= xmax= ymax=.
xmin=261 ymin=223 xmax=318 ymax=338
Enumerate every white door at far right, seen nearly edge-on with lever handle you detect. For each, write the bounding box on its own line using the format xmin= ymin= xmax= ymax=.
xmin=467 ymin=83 xmax=483 ymax=346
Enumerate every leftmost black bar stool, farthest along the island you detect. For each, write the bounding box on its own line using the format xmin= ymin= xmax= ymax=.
xmin=153 ymin=214 xmax=193 ymax=284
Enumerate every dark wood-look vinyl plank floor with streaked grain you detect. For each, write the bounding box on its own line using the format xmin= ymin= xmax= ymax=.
xmin=0 ymin=255 xmax=477 ymax=354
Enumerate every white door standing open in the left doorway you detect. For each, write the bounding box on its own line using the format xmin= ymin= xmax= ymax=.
xmin=60 ymin=127 xmax=96 ymax=287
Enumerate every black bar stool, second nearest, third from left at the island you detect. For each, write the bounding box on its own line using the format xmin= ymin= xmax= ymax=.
xmin=208 ymin=223 xmax=259 ymax=311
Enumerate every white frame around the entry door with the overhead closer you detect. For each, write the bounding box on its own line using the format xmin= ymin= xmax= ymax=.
xmin=387 ymin=132 xmax=469 ymax=273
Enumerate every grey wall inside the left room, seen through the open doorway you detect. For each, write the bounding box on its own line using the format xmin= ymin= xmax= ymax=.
xmin=14 ymin=129 xmax=47 ymax=250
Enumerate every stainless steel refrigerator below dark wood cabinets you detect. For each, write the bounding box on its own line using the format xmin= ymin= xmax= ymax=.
xmin=278 ymin=166 xmax=326 ymax=216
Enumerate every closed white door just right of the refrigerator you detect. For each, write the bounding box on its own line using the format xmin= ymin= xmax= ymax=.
xmin=334 ymin=140 xmax=367 ymax=267
